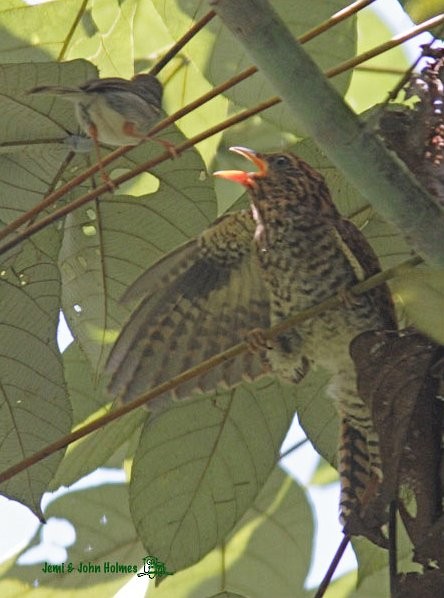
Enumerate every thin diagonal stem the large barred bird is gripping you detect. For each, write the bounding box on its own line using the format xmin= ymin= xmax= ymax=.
xmin=0 ymin=256 xmax=423 ymax=483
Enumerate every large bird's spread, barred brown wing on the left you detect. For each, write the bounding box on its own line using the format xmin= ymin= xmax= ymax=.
xmin=107 ymin=211 xmax=269 ymax=402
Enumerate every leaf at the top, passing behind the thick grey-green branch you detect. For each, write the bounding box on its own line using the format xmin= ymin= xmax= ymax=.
xmin=154 ymin=0 xmax=356 ymax=132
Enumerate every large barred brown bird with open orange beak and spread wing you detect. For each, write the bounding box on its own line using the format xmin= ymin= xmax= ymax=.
xmin=108 ymin=147 xmax=396 ymax=521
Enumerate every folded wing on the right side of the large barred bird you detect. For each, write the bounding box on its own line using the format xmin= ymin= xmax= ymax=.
xmin=336 ymin=219 xmax=397 ymax=330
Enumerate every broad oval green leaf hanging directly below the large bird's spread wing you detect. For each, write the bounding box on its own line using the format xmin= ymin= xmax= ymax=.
xmin=130 ymin=378 xmax=293 ymax=570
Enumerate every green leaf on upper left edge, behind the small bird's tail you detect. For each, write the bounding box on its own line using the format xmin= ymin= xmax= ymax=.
xmin=0 ymin=60 xmax=96 ymax=200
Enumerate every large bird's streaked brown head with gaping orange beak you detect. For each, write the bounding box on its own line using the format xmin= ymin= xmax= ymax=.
xmin=214 ymin=147 xmax=338 ymax=225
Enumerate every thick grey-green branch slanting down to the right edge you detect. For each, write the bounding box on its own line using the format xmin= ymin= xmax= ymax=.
xmin=210 ymin=0 xmax=444 ymax=267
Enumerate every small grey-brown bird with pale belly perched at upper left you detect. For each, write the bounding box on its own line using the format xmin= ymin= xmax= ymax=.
xmin=28 ymin=74 xmax=163 ymax=179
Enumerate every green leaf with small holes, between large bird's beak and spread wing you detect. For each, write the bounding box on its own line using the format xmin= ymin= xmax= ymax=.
xmin=60 ymin=131 xmax=216 ymax=372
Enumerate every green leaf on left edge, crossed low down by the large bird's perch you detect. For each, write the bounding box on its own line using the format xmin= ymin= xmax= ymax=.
xmin=0 ymin=211 xmax=72 ymax=518
